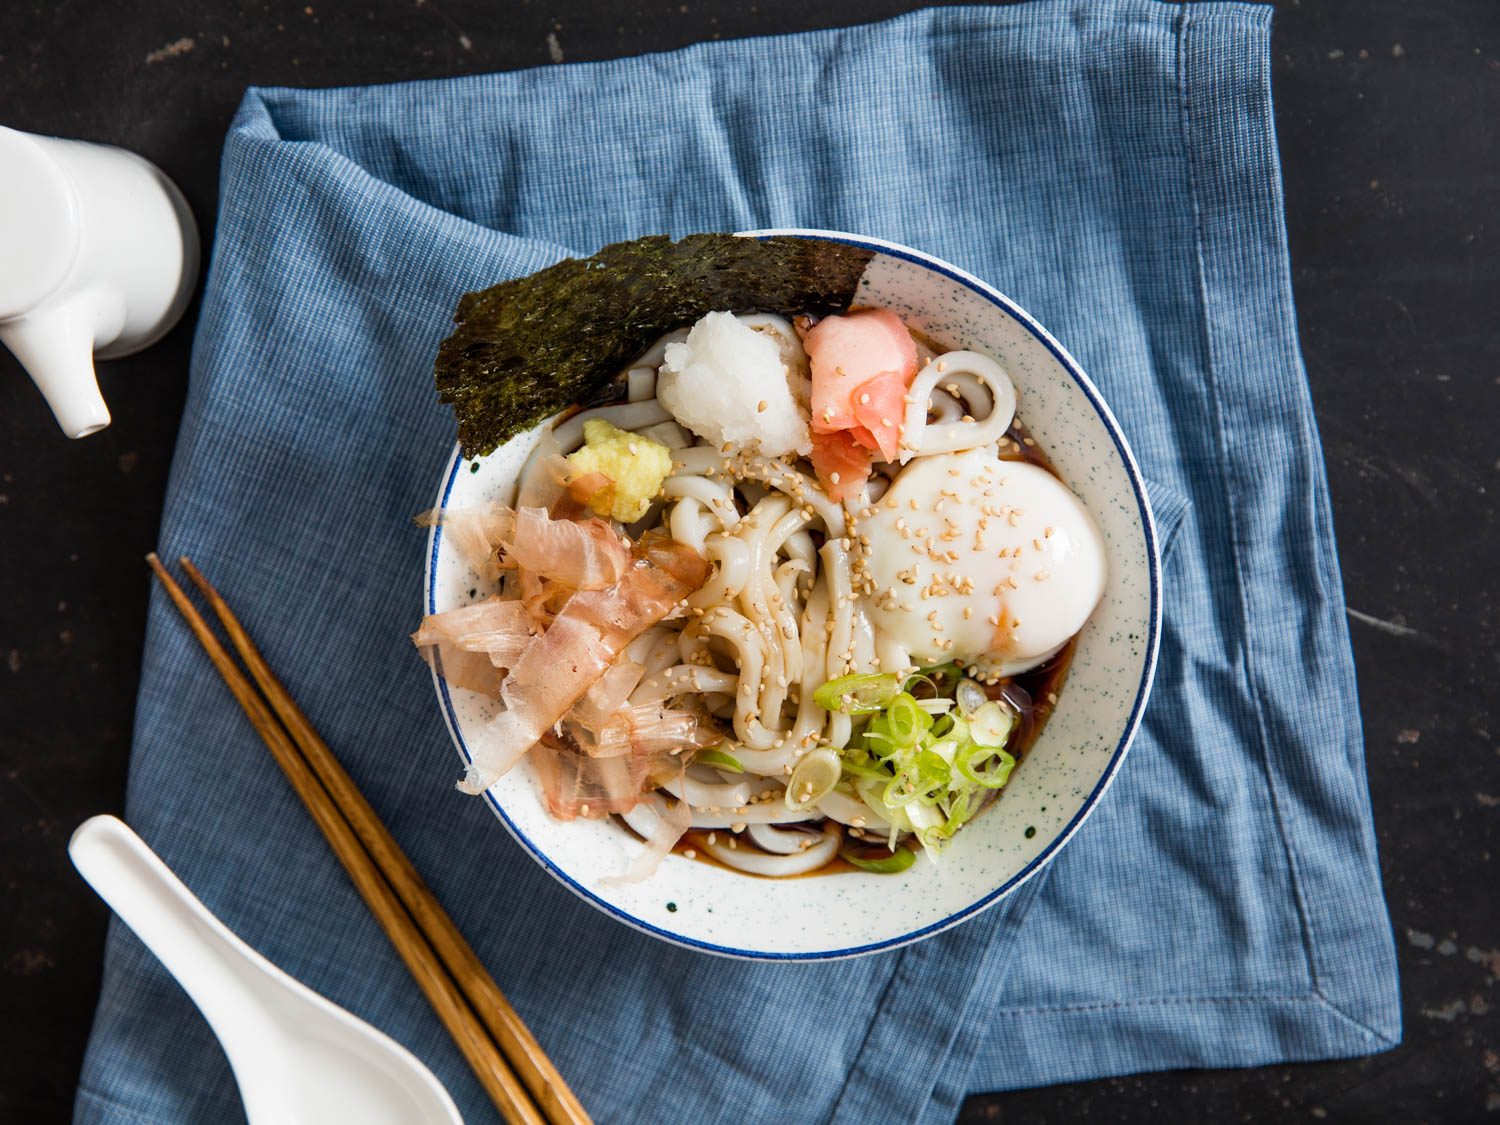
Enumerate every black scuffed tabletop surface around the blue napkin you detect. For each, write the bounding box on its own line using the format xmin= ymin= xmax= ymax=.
xmin=0 ymin=0 xmax=1500 ymax=1122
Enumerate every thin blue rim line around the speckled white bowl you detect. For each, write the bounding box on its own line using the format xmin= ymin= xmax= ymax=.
xmin=423 ymin=228 xmax=1161 ymax=962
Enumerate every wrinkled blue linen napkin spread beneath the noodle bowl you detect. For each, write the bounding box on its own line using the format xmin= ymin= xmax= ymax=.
xmin=77 ymin=0 xmax=1400 ymax=1122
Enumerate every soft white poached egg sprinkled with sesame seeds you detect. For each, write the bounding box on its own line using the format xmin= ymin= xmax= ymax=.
xmin=858 ymin=450 xmax=1106 ymax=680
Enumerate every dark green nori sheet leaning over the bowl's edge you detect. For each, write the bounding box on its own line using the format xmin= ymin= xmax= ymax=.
xmin=434 ymin=234 xmax=875 ymax=458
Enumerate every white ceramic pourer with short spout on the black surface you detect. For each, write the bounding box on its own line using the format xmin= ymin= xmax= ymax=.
xmin=0 ymin=126 xmax=198 ymax=438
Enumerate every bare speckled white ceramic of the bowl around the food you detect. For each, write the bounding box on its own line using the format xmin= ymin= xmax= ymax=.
xmin=423 ymin=230 xmax=1161 ymax=960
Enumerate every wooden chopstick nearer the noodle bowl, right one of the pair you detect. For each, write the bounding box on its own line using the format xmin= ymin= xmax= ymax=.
xmin=179 ymin=558 xmax=590 ymax=1125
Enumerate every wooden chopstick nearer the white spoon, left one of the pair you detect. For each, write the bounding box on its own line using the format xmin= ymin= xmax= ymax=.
xmin=146 ymin=552 xmax=558 ymax=1125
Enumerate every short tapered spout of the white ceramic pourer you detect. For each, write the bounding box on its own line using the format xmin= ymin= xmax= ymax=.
xmin=0 ymin=292 xmax=110 ymax=438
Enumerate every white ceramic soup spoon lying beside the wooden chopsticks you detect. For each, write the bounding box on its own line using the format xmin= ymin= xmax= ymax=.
xmin=68 ymin=816 xmax=464 ymax=1125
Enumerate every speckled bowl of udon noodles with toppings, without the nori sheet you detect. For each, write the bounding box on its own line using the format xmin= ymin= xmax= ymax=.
xmin=414 ymin=230 xmax=1161 ymax=960
